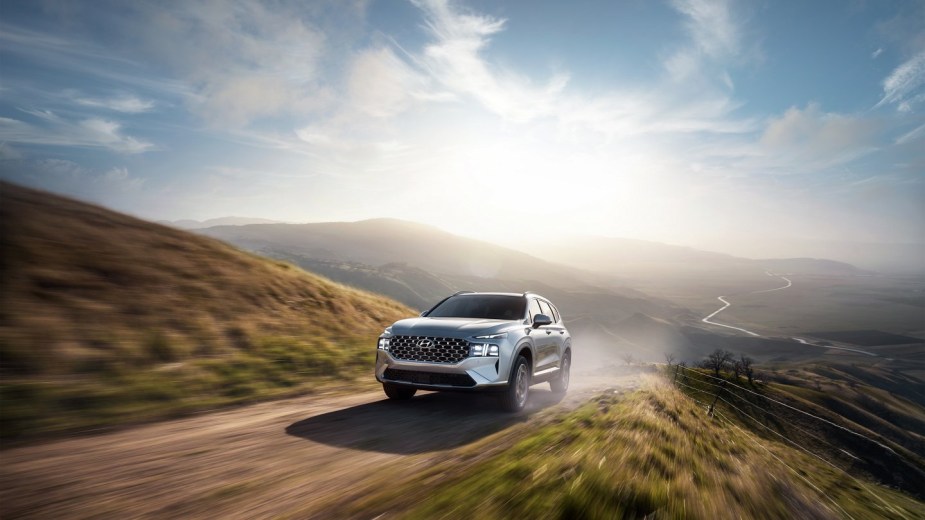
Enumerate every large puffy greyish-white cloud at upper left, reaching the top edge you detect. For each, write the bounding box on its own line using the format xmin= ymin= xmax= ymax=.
xmin=129 ymin=0 xmax=326 ymax=127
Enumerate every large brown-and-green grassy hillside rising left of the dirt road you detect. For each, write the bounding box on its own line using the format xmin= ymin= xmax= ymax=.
xmin=0 ymin=183 xmax=414 ymax=439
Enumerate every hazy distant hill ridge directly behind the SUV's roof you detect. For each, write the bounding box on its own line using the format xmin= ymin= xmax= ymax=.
xmin=197 ymin=219 xmax=680 ymax=312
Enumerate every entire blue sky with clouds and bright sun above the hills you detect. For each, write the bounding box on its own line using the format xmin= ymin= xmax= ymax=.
xmin=0 ymin=0 xmax=925 ymax=266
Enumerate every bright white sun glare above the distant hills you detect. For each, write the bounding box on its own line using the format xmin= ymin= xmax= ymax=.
xmin=409 ymin=126 xmax=679 ymax=246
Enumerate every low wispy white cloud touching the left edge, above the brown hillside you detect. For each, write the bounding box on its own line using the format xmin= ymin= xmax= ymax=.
xmin=0 ymin=110 xmax=155 ymax=154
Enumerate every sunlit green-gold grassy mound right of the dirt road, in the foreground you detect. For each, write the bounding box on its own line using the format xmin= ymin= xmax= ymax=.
xmin=322 ymin=380 xmax=925 ymax=519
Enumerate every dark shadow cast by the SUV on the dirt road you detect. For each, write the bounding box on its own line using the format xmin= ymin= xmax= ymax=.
xmin=286 ymin=388 xmax=562 ymax=455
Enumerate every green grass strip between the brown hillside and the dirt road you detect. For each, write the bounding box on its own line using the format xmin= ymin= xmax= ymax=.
xmin=0 ymin=336 xmax=374 ymax=441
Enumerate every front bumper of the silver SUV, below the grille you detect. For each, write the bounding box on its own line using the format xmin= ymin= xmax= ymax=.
xmin=376 ymin=350 xmax=507 ymax=392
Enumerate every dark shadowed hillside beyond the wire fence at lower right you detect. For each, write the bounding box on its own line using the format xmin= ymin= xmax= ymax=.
xmin=673 ymin=363 xmax=925 ymax=498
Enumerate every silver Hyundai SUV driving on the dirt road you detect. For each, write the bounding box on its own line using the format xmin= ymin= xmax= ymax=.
xmin=376 ymin=291 xmax=572 ymax=412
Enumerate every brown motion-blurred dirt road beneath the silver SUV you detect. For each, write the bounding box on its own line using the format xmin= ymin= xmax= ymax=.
xmin=0 ymin=370 xmax=639 ymax=519
